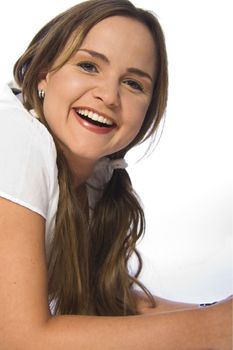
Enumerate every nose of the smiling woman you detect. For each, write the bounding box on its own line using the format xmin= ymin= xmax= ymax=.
xmin=93 ymin=80 xmax=120 ymax=108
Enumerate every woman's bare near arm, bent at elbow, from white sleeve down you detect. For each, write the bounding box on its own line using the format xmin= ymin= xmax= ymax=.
xmin=0 ymin=198 xmax=231 ymax=350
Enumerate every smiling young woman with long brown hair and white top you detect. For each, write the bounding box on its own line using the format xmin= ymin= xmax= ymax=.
xmin=0 ymin=0 xmax=231 ymax=350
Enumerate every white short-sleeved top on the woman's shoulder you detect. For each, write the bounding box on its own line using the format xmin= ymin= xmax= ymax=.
xmin=0 ymin=85 xmax=59 ymax=254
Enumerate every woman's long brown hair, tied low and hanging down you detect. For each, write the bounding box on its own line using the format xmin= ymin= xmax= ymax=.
xmin=14 ymin=0 xmax=168 ymax=315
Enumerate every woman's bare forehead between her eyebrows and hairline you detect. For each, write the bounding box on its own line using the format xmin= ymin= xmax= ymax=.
xmin=81 ymin=16 xmax=156 ymax=75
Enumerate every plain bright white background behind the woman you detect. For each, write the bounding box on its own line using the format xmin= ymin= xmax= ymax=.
xmin=0 ymin=0 xmax=233 ymax=302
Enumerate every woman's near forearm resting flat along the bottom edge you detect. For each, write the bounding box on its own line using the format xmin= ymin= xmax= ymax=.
xmin=28 ymin=309 xmax=231 ymax=350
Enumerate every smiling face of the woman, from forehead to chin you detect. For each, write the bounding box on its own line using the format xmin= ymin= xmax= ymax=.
xmin=38 ymin=16 xmax=156 ymax=170
